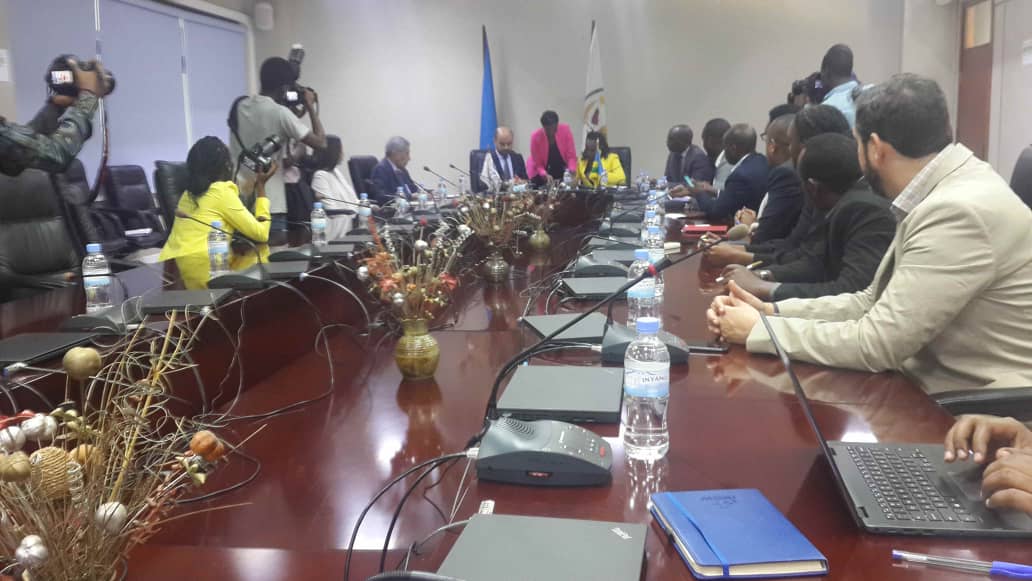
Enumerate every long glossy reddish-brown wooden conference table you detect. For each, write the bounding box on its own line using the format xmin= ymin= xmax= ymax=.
xmin=0 ymin=203 xmax=1032 ymax=581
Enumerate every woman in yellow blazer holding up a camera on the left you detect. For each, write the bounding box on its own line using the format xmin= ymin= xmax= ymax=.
xmin=160 ymin=135 xmax=276 ymax=289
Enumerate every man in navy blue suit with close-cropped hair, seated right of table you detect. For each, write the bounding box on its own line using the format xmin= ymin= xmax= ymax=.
xmin=692 ymin=123 xmax=768 ymax=222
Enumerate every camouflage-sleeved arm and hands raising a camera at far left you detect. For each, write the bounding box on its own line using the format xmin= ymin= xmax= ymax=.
xmin=0 ymin=61 xmax=111 ymax=175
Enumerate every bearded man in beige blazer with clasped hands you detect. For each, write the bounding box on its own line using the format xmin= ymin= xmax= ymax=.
xmin=706 ymin=74 xmax=1032 ymax=393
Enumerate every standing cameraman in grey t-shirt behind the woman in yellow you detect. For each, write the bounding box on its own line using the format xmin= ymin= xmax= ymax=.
xmin=229 ymin=57 xmax=326 ymax=236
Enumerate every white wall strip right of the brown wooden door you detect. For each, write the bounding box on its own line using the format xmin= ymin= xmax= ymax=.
xmin=989 ymin=0 xmax=1032 ymax=181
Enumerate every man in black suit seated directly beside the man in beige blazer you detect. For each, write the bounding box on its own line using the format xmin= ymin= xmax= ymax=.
xmin=724 ymin=133 xmax=896 ymax=300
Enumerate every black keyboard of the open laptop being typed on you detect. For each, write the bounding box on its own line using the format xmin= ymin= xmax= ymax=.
xmin=846 ymin=446 xmax=978 ymax=525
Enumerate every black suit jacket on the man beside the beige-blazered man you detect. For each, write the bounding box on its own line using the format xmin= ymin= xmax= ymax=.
xmin=756 ymin=182 xmax=896 ymax=300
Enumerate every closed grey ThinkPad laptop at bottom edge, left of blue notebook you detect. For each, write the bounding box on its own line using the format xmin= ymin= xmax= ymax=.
xmin=438 ymin=514 xmax=647 ymax=581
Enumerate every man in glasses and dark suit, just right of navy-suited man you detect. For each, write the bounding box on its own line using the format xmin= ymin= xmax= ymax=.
xmin=740 ymin=115 xmax=804 ymax=244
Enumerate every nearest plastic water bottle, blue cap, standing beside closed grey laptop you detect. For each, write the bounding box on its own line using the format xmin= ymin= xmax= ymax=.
xmin=620 ymin=317 xmax=670 ymax=460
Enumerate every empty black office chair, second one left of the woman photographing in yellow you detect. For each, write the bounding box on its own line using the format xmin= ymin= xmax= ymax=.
xmin=103 ymin=165 xmax=168 ymax=248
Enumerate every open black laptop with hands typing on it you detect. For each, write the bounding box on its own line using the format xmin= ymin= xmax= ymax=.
xmin=763 ymin=318 xmax=1032 ymax=537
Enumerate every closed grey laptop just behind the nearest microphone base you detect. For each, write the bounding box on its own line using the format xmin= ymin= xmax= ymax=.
xmin=497 ymin=365 xmax=623 ymax=423
